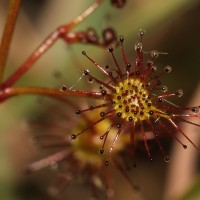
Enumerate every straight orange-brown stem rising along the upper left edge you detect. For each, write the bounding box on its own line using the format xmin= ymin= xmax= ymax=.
xmin=0 ymin=0 xmax=21 ymax=83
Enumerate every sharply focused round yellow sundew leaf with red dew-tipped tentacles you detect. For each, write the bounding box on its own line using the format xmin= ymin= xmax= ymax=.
xmin=59 ymin=30 xmax=200 ymax=165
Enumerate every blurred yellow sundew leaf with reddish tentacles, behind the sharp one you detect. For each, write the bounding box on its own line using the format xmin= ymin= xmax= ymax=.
xmin=26 ymin=100 xmax=139 ymax=200
